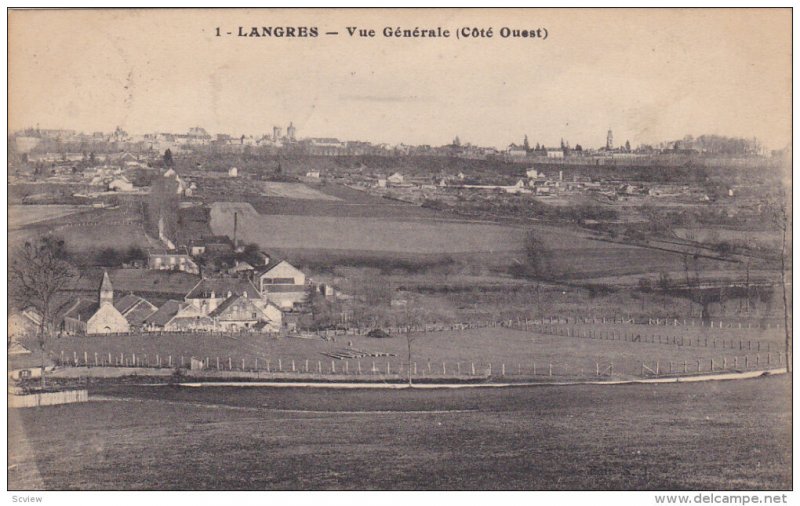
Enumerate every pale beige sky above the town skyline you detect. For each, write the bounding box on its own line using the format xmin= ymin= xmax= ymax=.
xmin=9 ymin=9 xmax=791 ymax=149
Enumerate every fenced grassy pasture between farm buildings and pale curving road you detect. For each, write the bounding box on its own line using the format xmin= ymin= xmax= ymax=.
xmin=34 ymin=325 xmax=783 ymax=378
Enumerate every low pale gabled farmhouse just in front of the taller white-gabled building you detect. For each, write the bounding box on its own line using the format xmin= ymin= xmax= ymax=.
xmin=209 ymin=291 xmax=283 ymax=332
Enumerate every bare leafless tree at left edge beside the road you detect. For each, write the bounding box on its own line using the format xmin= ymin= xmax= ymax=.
xmin=9 ymin=236 xmax=78 ymax=388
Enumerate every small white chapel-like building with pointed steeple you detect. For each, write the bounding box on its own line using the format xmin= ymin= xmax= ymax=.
xmin=62 ymin=272 xmax=130 ymax=335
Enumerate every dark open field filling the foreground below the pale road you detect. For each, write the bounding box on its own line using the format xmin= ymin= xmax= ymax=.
xmin=8 ymin=376 xmax=792 ymax=490
